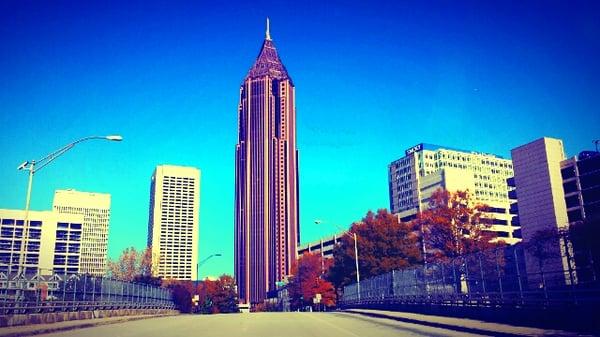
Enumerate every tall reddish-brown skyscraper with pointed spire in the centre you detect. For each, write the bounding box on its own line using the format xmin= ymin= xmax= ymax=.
xmin=235 ymin=19 xmax=299 ymax=303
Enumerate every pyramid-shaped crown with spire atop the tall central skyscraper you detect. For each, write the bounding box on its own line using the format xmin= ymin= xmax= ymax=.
xmin=246 ymin=18 xmax=291 ymax=81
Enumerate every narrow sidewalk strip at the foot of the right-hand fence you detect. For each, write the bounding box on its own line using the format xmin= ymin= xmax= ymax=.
xmin=344 ymin=309 xmax=591 ymax=337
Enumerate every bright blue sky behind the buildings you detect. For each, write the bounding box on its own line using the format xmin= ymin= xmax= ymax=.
xmin=0 ymin=0 xmax=600 ymax=276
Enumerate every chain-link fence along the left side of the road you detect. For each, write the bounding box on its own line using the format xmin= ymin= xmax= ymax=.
xmin=0 ymin=272 xmax=174 ymax=314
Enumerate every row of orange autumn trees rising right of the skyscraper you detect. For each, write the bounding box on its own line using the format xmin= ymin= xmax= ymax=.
xmin=288 ymin=189 xmax=505 ymax=309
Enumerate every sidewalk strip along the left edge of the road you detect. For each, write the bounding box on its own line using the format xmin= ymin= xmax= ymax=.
xmin=0 ymin=315 xmax=169 ymax=337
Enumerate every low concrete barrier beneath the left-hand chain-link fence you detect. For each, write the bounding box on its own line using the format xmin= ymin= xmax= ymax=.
xmin=0 ymin=309 xmax=179 ymax=327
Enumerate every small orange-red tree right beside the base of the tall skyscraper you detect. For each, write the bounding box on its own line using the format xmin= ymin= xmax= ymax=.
xmin=288 ymin=253 xmax=335 ymax=310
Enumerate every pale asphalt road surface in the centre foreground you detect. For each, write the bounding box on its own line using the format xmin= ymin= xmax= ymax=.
xmin=39 ymin=312 xmax=490 ymax=337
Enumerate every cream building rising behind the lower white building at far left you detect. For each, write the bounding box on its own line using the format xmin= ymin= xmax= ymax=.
xmin=53 ymin=190 xmax=110 ymax=275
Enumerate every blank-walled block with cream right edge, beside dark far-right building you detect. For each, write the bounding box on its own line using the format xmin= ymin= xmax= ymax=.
xmin=511 ymin=137 xmax=574 ymax=288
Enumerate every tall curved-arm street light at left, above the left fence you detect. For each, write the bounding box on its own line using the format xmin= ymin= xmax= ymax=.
xmin=17 ymin=135 xmax=123 ymax=275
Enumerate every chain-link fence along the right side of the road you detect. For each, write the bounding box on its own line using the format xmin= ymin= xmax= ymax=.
xmin=340 ymin=236 xmax=600 ymax=307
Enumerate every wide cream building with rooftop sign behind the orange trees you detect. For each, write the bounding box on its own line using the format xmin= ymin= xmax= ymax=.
xmin=388 ymin=143 xmax=520 ymax=244
